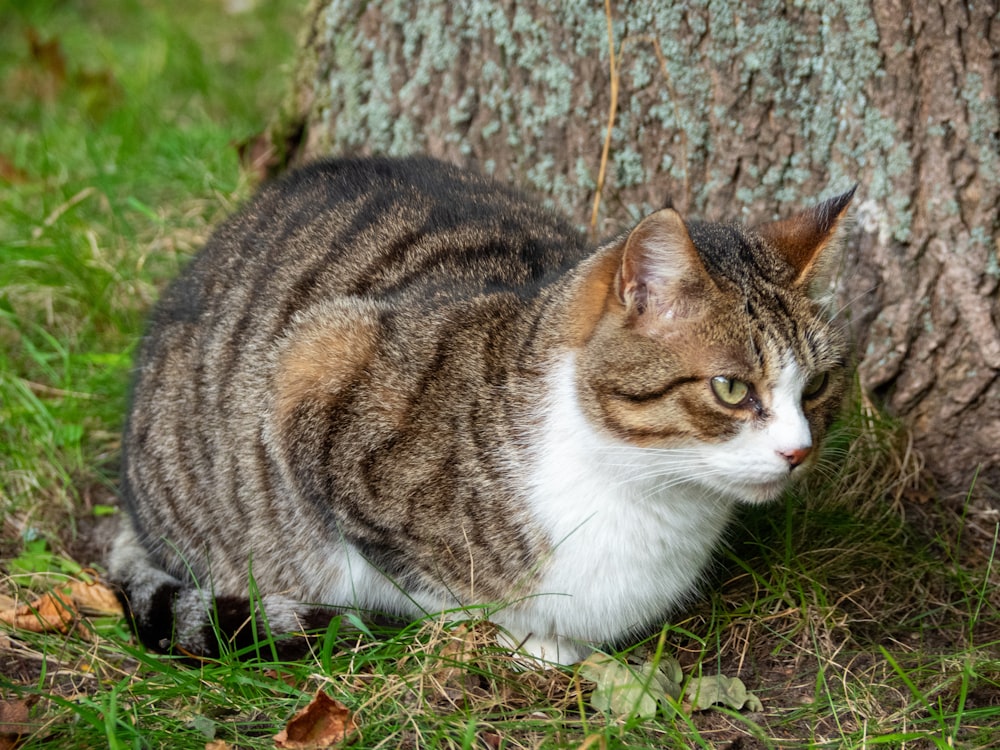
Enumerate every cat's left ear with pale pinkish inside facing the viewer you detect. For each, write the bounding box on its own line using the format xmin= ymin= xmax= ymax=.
xmin=616 ymin=208 xmax=713 ymax=318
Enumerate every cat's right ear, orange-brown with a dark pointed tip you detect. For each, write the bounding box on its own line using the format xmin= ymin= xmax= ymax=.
xmin=757 ymin=185 xmax=858 ymax=296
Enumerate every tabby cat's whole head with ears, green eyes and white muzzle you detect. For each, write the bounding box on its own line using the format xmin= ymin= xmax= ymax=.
xmin=577 ymin=190 xmax=854 ymax=502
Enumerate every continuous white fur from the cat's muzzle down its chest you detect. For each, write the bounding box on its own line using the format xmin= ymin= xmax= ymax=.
xmin=492 ymin=354 xmax=811 ymax=663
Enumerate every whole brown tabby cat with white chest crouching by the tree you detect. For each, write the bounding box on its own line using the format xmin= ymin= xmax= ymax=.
xmin=109 ymin=157 xmax=854 ymax=664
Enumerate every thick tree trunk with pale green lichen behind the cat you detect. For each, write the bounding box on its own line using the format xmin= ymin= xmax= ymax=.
xmin=276 ymin=0 xmax=1000 ymax=502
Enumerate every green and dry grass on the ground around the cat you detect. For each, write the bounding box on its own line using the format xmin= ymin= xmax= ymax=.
xmin=0 ymin=0 xmax=1000 ymax=748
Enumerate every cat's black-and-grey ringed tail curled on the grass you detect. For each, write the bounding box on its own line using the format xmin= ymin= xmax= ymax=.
xmin=108 ymin=519 xmax=340 ymax=659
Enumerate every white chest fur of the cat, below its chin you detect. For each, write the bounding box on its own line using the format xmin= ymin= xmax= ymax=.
xmin=493 ymin=357 xmax=734 ymax=662
